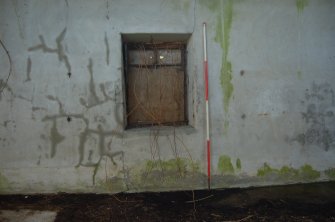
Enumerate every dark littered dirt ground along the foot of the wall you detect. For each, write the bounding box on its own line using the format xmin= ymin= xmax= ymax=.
xmin=0 ymin=183 xmax=335 ymax=222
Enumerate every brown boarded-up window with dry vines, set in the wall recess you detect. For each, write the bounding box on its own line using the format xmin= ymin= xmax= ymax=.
xmin=123 ymin=42 xmax=187 ymax=128
